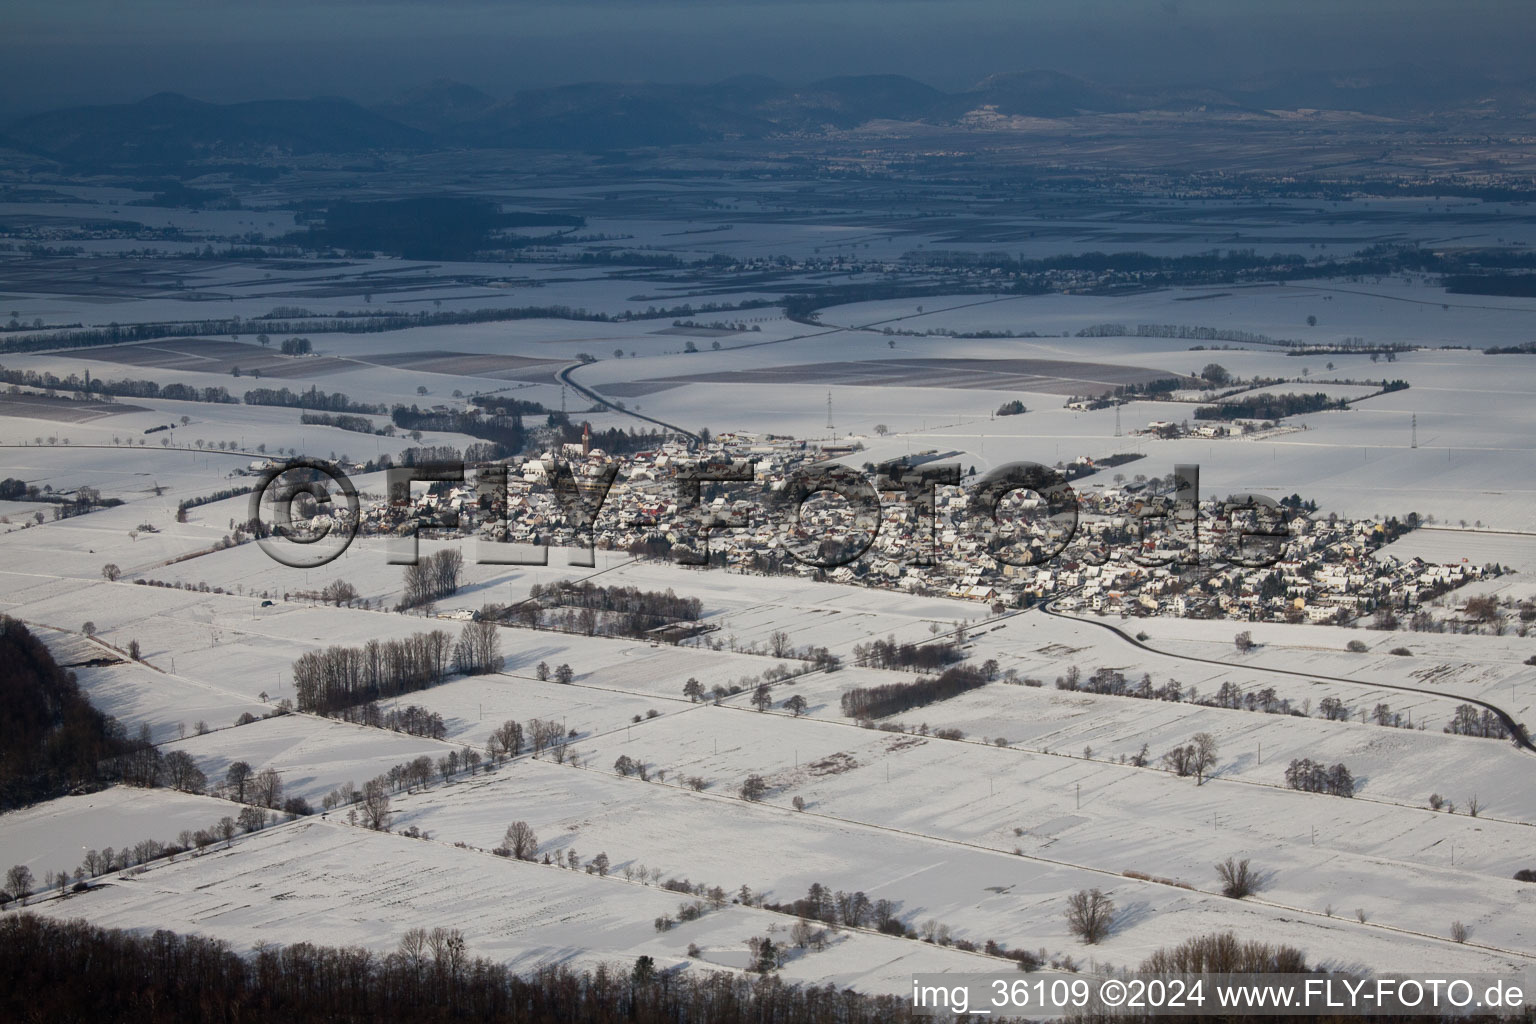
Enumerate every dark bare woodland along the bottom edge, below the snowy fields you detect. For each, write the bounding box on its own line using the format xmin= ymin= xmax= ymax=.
xmin=0 ymin=913 xmax=919 ymax=1024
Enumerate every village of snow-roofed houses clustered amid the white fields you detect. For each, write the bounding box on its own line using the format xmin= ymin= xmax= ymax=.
xmin=333 ymin=434 xmax=1499 ymax=622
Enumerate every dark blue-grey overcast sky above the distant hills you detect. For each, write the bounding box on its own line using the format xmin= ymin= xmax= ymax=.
xmin=0 ymin=0 xmax=1536 ymax=115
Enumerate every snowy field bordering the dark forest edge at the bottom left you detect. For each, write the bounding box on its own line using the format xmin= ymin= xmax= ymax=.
xmin=24 ymin=818 xmax=1001 ymax=992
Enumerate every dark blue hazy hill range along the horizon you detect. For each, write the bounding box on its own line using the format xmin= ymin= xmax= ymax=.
xmin=12 ymin=66 xmax=1536 ymax=167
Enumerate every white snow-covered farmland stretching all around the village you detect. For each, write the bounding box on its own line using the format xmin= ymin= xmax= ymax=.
xmin=0 ymin=214 xmax=1536 ymax=992
